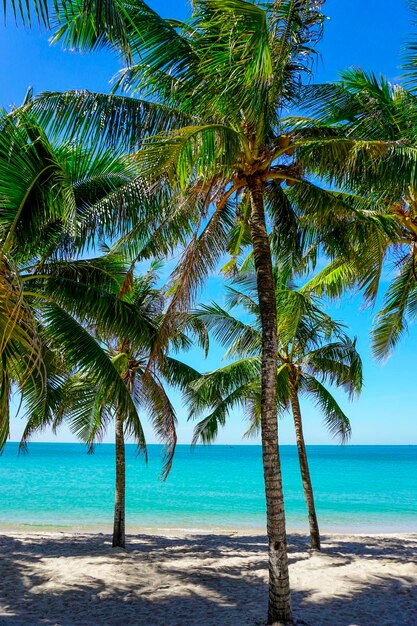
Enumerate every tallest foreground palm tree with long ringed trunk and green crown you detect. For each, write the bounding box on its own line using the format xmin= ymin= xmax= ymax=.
xmin=25 ymin=0 xmax=332 ymax=623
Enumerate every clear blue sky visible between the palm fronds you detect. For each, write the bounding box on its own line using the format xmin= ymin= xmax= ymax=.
xmin=0 ymin=0 xmax=417 ymax=444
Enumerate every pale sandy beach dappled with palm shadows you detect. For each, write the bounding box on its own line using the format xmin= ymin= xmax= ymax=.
xmin=0 ymin=533 xmax=417 ymax=626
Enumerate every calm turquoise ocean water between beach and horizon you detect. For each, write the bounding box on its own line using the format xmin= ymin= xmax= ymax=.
xmin=0 ymin=443 xmax=417 ymax=532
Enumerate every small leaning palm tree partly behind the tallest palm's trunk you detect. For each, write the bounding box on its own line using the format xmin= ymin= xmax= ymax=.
xmin=188 ymin=266 xmax=362 ymax=550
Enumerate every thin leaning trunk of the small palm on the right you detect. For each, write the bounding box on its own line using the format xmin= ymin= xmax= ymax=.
xmin=290 ymin=385 xmax=320 ymax=550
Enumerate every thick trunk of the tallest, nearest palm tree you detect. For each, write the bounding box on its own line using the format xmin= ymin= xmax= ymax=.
xmin=248 ymin=178 xmax=291 ymax=624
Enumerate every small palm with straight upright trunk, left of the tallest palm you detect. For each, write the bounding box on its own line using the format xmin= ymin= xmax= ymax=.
xmin=45 ymin=264 xmax=205 ymax=548
